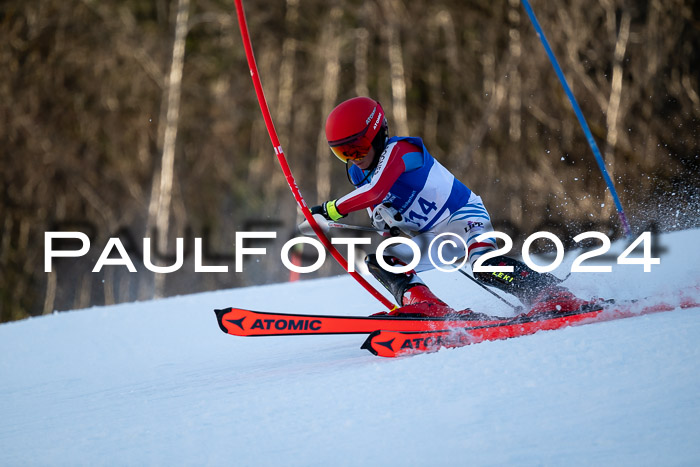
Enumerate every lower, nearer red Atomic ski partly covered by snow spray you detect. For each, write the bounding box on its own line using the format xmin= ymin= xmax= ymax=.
xmin=362 ymin=297 xmax=700 ymax=357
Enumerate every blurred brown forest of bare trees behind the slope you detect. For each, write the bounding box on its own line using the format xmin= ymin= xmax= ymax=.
xmin=0 ymin=0 xmax=700 ymax=321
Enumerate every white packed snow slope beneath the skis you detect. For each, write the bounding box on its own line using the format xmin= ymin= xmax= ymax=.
xmin=0 ymin=230 xmax=700 ymax=466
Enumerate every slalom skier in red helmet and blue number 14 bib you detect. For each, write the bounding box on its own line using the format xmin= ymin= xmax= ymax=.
xmin=311 ymin=97 xmax=573 ymax=317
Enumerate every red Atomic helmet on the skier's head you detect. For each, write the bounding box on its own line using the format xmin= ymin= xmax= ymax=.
xmin=326 ymin=97 xmax=387 ymax=162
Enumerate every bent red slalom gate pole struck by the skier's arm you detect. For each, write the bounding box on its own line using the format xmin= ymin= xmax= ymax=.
xmin=234 ymin=0 xmax=396 ymax=310
